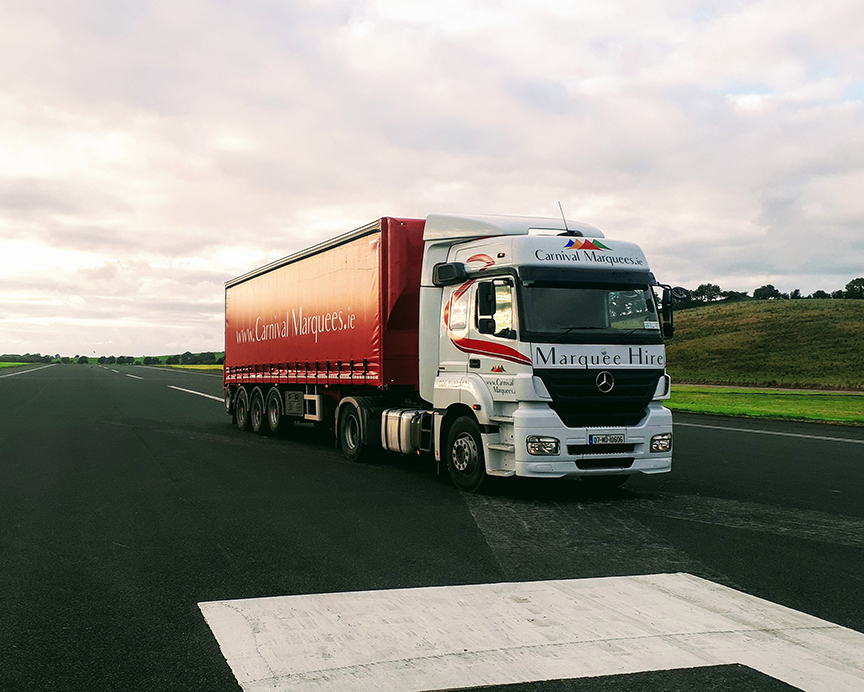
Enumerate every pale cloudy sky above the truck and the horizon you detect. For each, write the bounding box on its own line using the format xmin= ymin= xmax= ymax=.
xmin=0 ymin=0 xmax=864 ymax=356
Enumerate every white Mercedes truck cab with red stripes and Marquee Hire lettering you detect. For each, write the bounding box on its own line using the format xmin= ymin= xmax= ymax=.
xmin=414 ymin=215 xmax=672 ymax=491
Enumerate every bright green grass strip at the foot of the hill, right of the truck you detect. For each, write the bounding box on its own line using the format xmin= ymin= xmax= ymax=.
xmin=666 ymin=384 xmax=864 ymax=425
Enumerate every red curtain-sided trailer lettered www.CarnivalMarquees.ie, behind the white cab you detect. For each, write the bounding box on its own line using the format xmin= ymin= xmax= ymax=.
xmin=224 ymin=217 xmax=425 ymax=431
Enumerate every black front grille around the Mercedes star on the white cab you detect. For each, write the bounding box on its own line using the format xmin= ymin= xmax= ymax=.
xmin=534 ymin=368 xmax=663 ymax=428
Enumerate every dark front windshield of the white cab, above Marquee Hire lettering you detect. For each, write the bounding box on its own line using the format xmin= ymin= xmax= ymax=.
xmin=520 ymin=282 xmax=662 ymax=343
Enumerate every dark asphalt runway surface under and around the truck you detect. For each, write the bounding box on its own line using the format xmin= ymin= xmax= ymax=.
xmin=0 ymin=365 xmax=864 ymax=692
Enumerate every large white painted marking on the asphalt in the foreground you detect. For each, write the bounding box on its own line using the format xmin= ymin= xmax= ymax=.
xmin=199 ymin=574 xmax=864 ymax=692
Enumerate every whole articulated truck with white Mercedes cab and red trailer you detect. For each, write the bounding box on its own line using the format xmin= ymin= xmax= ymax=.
xmin=223 ymin=214 xmax=687 ymax=492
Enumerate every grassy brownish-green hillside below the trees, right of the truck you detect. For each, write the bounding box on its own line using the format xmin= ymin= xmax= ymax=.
xmin=667 ymin=299 xmax=864 ymax=390
